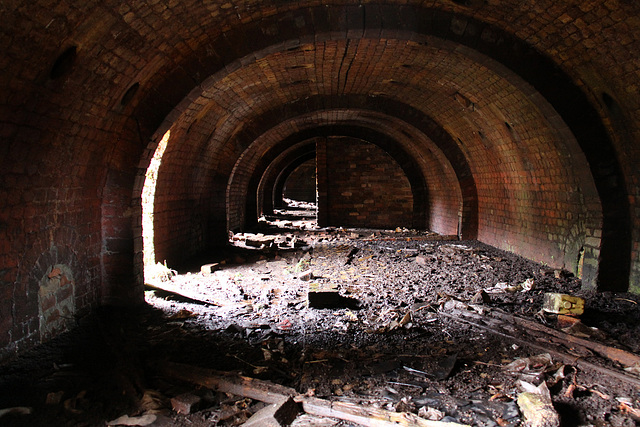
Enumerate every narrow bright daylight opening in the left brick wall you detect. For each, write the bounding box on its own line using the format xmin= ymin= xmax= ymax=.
xmin=142 ymin=130 xmax=171 ymax=281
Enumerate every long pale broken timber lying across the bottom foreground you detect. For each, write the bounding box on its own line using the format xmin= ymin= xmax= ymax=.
xmin=160 ymin=363 xmax=465 ymax=427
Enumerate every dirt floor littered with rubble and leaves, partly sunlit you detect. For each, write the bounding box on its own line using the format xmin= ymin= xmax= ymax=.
xmin=0 ymin=202 xmax=640 ymax=426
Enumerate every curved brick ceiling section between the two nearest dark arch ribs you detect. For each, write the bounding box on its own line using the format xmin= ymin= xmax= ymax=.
xmin=154 ymin=36 xmax=599 ymax=270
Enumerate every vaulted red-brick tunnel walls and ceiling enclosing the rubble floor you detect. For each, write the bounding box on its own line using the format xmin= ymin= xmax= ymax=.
xmin=0 ymin=0 xmax=640 ymax=372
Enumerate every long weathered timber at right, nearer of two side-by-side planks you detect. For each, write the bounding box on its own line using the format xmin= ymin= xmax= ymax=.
xmin=439 ymin=309 xmax=640 ymax=387
